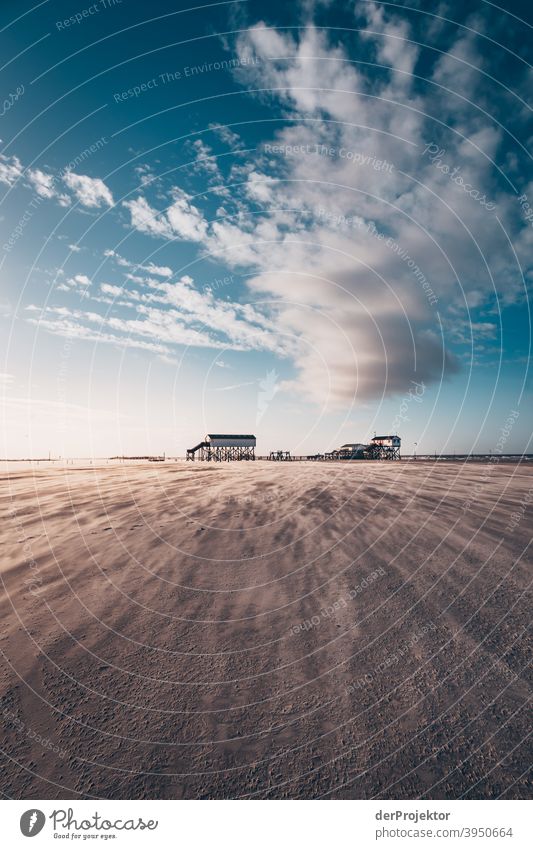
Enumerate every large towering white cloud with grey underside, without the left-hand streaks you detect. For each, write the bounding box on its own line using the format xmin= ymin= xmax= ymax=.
xmin=115 ymin=2 xmax=527 ymax=405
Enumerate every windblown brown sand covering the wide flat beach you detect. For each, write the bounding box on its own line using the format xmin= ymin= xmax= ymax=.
xmin=0 ymin=462 xmax=533 ymax=799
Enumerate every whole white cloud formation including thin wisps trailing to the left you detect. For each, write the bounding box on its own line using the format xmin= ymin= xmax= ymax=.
xmin=9 ymin=2 xmax=531 ymax=406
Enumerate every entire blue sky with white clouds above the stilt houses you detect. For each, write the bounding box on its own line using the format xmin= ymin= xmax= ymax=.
xmin=0 ymin=0 xmax=533 ymax=456
